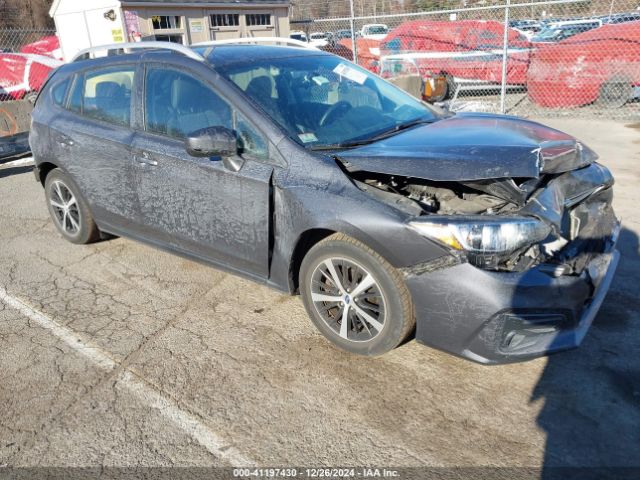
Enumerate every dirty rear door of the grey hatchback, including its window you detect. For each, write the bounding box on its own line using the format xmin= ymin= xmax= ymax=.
xmin=51 ymin=64 xmax=137 ymax=231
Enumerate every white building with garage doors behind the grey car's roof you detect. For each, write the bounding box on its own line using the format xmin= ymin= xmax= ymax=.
xmin=49 ymin=0 xmax=289 ymax=60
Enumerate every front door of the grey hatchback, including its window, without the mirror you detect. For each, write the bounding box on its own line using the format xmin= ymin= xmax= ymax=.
xmin=133 ymin=66 xmax=273 ymax=278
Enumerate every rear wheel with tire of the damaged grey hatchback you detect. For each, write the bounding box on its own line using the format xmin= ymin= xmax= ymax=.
xmin=44 ymin=168 xmax=100 ymax=244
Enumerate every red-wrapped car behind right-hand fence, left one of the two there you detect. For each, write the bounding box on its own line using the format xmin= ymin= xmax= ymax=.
xmin=380 ymin=20 xmax=531 ymax=100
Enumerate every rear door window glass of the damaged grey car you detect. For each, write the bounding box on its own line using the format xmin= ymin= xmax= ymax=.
xmin=68 ymin=66 xmax=135 ymax=126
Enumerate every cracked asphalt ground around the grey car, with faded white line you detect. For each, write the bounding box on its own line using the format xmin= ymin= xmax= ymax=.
xmin=0 ymin=119 xmax=640 ymax=478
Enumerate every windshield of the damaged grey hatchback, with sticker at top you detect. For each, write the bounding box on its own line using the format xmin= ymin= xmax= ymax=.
xmin=217 ymin=55 xmax=439 ymax=147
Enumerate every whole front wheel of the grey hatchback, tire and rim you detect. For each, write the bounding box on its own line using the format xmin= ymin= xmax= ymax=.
xmin=300 ymin=234 xmax=415 ymax=356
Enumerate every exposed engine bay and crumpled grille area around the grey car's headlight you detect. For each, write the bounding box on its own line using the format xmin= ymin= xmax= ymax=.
xmin=343 ymin=163 xmax=618 ymax=276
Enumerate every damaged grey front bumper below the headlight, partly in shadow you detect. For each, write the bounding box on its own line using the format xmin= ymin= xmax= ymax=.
xmin=405 ymin=221 xmax=620 ymax=364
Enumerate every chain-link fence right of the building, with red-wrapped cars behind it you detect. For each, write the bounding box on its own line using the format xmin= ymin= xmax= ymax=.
xmin=291 ymin=0 xmax=640 ymax=120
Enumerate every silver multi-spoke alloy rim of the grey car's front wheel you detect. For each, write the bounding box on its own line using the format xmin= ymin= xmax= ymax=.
xmin=311 ymin=258 xmax=386 ymax=342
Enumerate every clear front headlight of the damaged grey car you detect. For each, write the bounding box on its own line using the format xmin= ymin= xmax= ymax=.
xmin=409 ymin=216 xmax=551 ymax=266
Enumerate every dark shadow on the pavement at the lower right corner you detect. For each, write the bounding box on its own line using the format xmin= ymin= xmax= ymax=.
xmin=531 ymin=228 xmax=640 ymax=480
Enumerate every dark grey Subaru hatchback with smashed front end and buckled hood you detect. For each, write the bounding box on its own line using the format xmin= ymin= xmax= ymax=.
xmin=30 ymin=45 xmax=619 ymax=363
